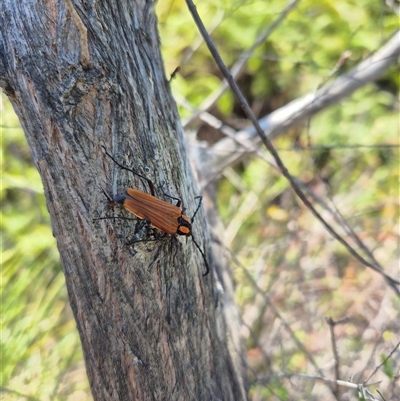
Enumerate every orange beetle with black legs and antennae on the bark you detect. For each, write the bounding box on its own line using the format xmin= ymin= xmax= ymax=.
xmin=95 ymin=147 xmax=210 ymax=276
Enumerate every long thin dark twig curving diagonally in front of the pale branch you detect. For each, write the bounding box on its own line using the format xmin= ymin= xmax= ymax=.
xmin=186 ymin=0 xmax=400 ymax=297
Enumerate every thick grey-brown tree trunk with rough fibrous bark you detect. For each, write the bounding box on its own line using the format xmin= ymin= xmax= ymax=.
xmin=0 ymin=0 xmax=246 ymax=400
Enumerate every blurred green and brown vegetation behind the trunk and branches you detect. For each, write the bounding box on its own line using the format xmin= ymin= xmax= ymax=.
xmin=0 ymin=0 xmax=400 ymax=401
